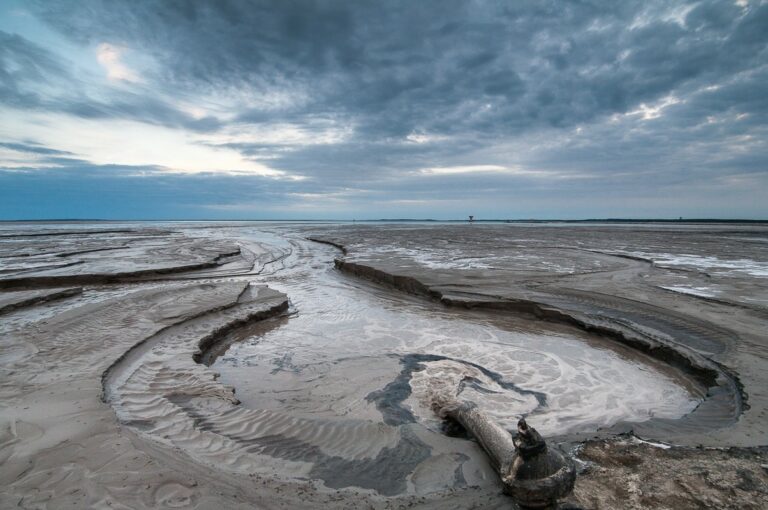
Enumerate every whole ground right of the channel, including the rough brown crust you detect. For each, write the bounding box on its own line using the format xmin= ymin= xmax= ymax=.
xmin=306 ymin=224 xmax=768 ymax=508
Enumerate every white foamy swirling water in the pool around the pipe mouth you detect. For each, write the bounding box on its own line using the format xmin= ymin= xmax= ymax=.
xmin=407 ymin=336 xmax=698 ymax=435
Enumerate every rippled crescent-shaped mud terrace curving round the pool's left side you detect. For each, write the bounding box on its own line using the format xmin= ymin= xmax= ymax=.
xmin=105 ymin=287 xmax=450 ymax=495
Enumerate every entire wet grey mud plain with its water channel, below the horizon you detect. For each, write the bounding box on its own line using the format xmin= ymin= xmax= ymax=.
xmin=0 ymin=223 xmax=768 ymax=508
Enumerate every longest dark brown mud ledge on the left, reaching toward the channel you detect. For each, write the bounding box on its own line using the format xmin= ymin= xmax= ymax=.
xmin=0 ymin=247 xmax=240 ymax=290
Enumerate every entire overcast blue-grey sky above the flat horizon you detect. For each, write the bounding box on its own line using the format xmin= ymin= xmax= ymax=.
xmin=0 ymin=0 xmax=768 ymax=219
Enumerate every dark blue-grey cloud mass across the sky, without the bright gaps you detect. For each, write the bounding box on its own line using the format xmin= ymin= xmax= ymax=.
xmin=0 ymin=0 xmax=768 ymax=217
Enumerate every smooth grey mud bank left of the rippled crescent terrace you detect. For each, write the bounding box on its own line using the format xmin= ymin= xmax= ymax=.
xmin=0 ymin=283 xmax=300 ymax=508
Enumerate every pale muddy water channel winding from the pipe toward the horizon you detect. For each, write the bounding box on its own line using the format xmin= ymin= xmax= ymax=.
xmin=182 ymin=227 xmax=701 ymax=495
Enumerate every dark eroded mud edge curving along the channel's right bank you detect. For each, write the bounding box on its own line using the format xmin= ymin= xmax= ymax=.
xmin=332 ymin=256 xmax=749 ymax=442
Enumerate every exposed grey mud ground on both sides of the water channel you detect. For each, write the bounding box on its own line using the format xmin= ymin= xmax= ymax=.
xmin=0 ymin=225 xmax=768 ymax=509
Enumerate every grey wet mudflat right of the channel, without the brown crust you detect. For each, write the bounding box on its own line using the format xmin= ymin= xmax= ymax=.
xmin=313 ymin=225 xmax=768 ymax=446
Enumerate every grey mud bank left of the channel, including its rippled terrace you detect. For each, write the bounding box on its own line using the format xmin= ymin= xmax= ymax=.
xmin=0 ymin=228 xmax=520 ymax=508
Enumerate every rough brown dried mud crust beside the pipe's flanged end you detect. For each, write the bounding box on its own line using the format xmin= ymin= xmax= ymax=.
xmin=570 ymin=438 xmax=768 ymax=510
